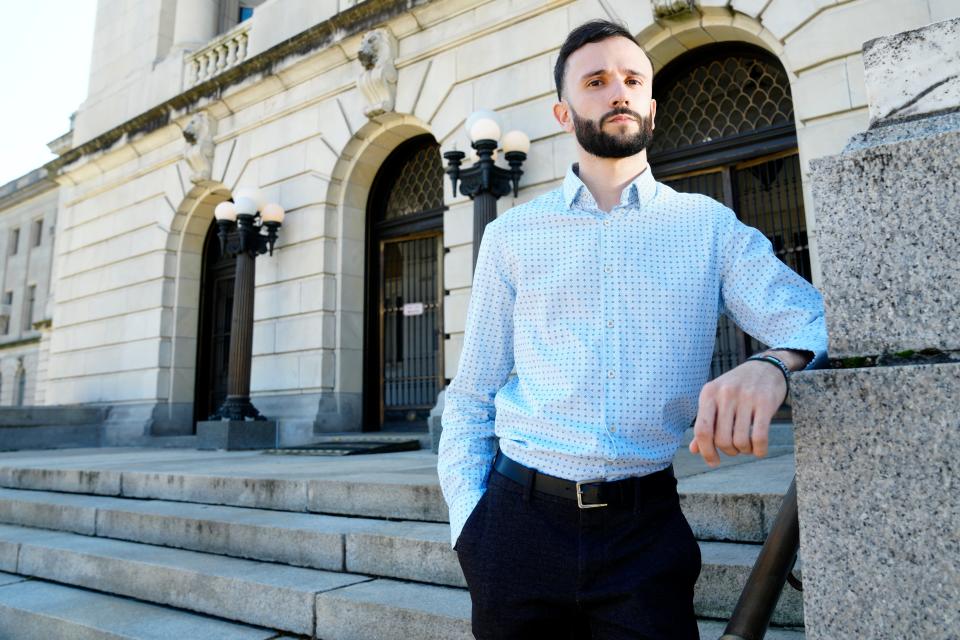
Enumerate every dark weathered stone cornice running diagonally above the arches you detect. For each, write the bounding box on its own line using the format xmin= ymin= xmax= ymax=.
xmin=48 ymin=0 xmax=432 ymax=176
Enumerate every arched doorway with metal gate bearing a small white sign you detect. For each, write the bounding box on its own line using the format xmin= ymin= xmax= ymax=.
xmin=363 ymin=135 xmax=446 ymax=431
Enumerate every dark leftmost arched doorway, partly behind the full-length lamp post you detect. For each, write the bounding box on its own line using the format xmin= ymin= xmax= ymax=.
xmin=193 ymin=222 xmax=237 ymax=428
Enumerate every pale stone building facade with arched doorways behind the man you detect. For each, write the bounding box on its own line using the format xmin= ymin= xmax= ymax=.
xmin=0 ymin=0 xmax=960 ymax=443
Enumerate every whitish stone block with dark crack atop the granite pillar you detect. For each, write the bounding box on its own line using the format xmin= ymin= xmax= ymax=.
xmin=863 ymin=18 xmax=960 ymax=126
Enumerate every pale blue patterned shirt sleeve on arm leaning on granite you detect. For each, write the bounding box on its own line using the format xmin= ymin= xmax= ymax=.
xmin=719 ymin=207 xmax=827 ymax=369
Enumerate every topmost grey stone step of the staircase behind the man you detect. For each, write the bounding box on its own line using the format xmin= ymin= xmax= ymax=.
xmin=0 ymin=450 xmax=794 ymax=542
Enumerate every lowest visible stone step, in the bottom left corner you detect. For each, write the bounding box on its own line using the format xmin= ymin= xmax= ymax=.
xmin=0 ymin=573 xmax=283 ymax=640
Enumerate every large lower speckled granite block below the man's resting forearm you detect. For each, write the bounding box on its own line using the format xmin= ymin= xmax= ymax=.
xmin=792 ymin=363 xmax=960 ymax=640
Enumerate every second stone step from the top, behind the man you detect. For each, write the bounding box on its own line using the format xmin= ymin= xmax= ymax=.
xmin=0 ymin=489 xmax=802 ymax=624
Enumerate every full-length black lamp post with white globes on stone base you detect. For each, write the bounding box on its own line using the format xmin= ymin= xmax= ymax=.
xmin=197 ymin=189 xmax=284 ymax=449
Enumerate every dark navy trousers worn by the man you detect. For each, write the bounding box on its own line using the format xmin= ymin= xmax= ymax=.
xmin=456 ymin=454 xmax=700 ymax=640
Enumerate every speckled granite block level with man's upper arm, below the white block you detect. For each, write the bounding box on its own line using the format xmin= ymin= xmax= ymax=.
xmin=811 ymin=125 xmax=960 ymax=357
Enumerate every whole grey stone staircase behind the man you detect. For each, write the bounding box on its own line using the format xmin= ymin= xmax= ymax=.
xmin=0 ymin=446 xmax=803 ymax=640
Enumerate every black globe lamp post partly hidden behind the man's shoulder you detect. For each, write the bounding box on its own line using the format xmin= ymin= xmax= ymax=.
xmin=443 ymin=110 xmax=530 ymax=267
